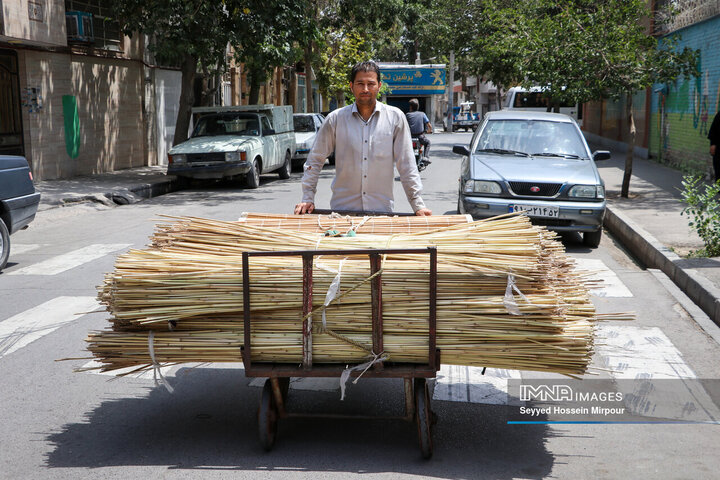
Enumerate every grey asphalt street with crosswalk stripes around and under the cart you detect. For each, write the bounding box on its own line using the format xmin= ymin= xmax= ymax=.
xmin=0 ymin=129 xmax=720 ymax=479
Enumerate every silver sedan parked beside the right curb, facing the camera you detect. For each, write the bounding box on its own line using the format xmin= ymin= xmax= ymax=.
xmin=453 ymin=111 xmax=610 ymax=248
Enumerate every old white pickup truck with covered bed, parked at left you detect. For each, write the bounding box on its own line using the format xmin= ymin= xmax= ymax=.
xmin=167 ymin=105 xmax=295 ymax=188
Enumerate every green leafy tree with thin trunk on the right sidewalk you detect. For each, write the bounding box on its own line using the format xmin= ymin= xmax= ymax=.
xmin=416 ymin=0 xmax=697 ymax=196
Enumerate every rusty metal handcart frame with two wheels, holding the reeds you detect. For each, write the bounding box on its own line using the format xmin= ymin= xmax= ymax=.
xmin=242 ymin=247 xmax=440 ymax=458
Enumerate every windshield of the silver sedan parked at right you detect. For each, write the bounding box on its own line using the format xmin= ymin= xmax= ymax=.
xmin=475 ymin=119 xmax=587 ymax=158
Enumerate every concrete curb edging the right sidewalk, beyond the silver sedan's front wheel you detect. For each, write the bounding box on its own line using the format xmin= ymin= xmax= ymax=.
xmin=604 ymin=205 xmax=720 ymax=325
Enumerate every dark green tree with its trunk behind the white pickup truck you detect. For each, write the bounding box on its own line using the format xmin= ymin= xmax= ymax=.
xmin=113 ymin=0 xmax=304 ymax=144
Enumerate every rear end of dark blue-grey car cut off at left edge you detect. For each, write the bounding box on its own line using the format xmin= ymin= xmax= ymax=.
xmin=0 ymin=155 xmax=40 ymax=270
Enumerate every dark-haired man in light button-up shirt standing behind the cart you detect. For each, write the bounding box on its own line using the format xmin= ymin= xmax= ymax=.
xmin=295 ymin=61 xmax=432 ymax=215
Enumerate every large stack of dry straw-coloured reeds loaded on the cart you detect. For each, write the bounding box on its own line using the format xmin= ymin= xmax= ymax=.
xmin=88 ymin=215 xmax=621 ymax=375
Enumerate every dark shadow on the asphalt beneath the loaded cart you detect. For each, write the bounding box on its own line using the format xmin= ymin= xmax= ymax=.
xmin=46 ymin=368 xmax=554 ymax=479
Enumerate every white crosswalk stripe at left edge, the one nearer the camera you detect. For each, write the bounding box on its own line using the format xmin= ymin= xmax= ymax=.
xmin=0 ymin=297 xmax=99 ymax=358
